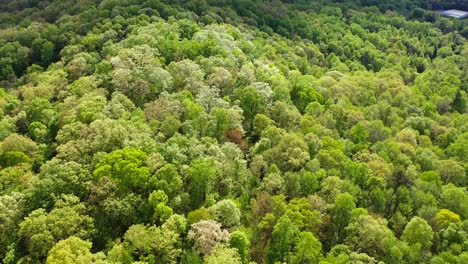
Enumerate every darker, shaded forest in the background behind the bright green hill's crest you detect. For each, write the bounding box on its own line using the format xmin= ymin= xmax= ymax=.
xmin=0 ymin=0 xmax=468 ymax=80
